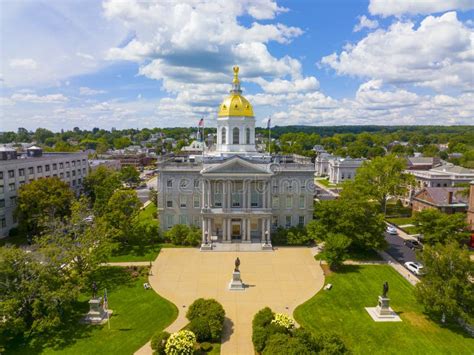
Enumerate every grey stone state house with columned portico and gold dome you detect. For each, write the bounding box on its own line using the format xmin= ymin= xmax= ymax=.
xmin=158 ymin=67 xmax=314 ymax=250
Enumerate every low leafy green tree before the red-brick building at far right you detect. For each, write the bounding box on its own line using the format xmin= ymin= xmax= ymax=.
xmin=414 ymin=209 xmax=469 ymax=245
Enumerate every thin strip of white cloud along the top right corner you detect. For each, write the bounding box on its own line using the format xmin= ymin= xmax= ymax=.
xmin=369 ymin=0 xmax=474 ymax=17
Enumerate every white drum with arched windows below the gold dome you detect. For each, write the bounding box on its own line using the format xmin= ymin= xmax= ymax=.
xmin=217 ymin=116 xmax=257 ymax=154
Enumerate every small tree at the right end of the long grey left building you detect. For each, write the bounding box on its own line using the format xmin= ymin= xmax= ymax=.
xmin=83 ymin=166 xmax=121 ymax=215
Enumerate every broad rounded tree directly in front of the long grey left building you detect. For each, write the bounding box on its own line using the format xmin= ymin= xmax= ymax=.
xmin=16 ymin=177 xmax=74 ymax=235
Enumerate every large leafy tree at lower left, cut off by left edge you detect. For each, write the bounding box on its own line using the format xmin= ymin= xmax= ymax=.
xmin=0 ymin=247 xmax=80 ymax=344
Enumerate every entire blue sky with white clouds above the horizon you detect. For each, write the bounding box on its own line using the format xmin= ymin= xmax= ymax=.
xmin=0 ymin=0 xmax=474 ymax=130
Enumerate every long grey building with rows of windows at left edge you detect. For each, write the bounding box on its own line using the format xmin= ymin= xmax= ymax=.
xmin=0 ymin=147 xmax=89 ymax=238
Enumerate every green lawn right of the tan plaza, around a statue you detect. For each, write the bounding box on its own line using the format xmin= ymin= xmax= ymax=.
xmin=294 ymin=265 xmax=474 ymax=354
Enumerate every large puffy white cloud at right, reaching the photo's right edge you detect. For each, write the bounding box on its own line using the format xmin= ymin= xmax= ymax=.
xmin=321 ymin=12 xmax=474 ymax=90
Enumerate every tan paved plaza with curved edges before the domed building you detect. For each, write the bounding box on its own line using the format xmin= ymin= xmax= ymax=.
xmin=135 ymin=248 xmax=324 ymax=355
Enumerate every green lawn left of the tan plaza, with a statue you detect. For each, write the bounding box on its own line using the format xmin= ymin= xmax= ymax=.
xmin=7 ymin=267 xmax=178 ymax=355
